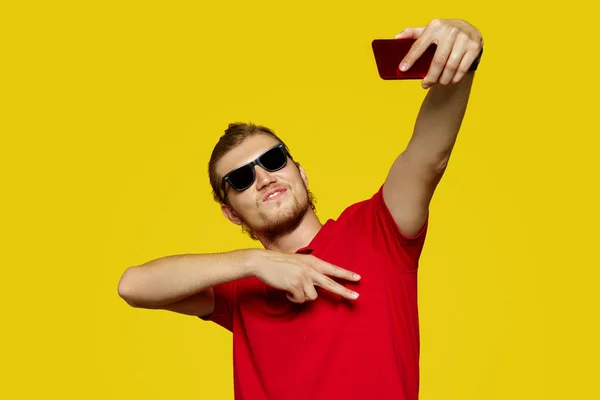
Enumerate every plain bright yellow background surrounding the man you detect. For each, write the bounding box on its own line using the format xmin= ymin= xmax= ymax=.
xmin=0 ymin=0 xmax=600 ymax=400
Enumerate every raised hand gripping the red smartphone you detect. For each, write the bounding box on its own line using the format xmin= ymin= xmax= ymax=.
xmin=396 ymin=19 xmax=483 ymax=89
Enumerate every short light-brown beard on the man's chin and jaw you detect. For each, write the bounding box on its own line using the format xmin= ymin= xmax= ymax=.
xmin=242 ymin=187 xmax=312 ymax=242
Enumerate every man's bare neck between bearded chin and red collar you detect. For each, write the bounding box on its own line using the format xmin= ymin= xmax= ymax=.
xmin=256 ymin=208 xmax=323 ymax=253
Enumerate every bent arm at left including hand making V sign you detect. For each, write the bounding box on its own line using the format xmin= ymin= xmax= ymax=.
xmin=118 ymin=249 xmax=360 ymax=317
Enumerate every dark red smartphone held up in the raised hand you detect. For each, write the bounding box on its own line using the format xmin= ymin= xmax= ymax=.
xmin=371 ymin=39 xmax=437 ymax=80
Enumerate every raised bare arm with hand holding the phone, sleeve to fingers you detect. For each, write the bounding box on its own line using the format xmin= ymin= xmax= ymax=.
xmin=383 ymin=20 xmax=483 ymax=237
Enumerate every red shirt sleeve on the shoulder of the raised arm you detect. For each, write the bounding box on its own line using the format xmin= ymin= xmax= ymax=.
xmin=352 ymin=185 xmax=429 ymax=272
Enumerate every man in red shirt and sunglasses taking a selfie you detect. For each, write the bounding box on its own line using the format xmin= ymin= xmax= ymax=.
xmin=119 ymin=20 xmax=483 ymax=400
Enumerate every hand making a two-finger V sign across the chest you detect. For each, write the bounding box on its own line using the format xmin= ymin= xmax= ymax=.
xmin=254 ymin=250 xmax=360 ymax=303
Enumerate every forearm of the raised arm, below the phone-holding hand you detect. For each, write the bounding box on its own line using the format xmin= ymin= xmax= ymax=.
xmin=405 ymin=72 xmax=474 ymax=168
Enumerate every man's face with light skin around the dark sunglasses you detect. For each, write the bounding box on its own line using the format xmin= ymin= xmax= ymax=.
xmin=216 ymin=134 xmax=309 ymax=237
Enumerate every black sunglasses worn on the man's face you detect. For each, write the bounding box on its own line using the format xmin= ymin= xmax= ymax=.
xmin=221 ymin=143 xmax=293 ymax=196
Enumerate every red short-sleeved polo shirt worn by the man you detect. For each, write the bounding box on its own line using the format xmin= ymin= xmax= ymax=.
xmin=204 ymin=188 xmax=428 ymax=400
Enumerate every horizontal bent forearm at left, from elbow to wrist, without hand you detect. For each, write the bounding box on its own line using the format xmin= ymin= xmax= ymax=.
xmin=119 ymin=249 xmax=260 ymax=308
